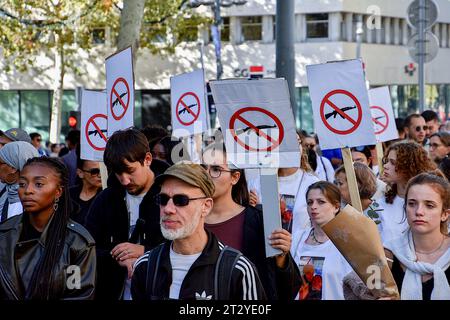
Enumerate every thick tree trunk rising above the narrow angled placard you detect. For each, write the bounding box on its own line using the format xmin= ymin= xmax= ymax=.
xmin=117 ymin=0 xmax=145 ymax=65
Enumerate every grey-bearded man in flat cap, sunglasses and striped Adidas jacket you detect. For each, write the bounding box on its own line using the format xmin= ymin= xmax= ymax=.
xmin=131 ymin=163 xmax=266 ymax=301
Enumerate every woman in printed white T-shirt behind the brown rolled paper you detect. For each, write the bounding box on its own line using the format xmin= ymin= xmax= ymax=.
xmin=291 ymin=181 xmax=352 ymax=300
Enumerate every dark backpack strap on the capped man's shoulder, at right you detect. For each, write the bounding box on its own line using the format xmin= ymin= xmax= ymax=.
xmin=214 ymin=246 xmax=242 ymax=300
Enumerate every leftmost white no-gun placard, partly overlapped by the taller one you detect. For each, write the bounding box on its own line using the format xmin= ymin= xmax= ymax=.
xmin=80 ymin=89 xmax=108 ymax=161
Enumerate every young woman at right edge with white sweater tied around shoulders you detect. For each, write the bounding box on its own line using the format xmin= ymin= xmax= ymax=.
xmin=385 ymin=173 xmax=450 ymax=300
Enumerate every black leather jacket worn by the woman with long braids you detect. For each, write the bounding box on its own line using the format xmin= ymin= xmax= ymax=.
xmin=0 ymin=214 xmax=96 ymax=300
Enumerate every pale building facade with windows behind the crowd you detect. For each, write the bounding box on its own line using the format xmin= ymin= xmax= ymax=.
xmin=0 ymin=0 xmax=450 ymax=137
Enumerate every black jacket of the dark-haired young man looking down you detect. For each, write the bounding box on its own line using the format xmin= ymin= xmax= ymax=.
xmin=86 ymin=160 xmax=168 ymax=300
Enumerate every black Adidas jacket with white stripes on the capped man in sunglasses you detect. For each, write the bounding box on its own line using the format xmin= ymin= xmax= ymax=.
xmin=131 ymin=231 xmax=266 ymax=301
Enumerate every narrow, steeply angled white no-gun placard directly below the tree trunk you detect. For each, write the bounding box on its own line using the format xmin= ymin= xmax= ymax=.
xmin=106 ymin=47 xmax=134 ymax=137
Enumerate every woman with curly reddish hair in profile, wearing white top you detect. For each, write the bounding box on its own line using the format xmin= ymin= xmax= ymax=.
xmin=378 ymin=141 xmax=436 ymax=243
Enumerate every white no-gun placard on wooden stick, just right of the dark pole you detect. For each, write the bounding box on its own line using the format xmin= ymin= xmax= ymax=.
xmin=306 ymin=60 xmax=376 ymax=150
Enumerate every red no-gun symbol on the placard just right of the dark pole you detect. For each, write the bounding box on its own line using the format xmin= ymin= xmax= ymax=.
xmin=320 ymin=89 xmax=362 ymax=135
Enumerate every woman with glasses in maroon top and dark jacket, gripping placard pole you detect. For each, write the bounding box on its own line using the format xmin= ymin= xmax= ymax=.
xmin=203 ymin=143 xmax=300 ymax=300
